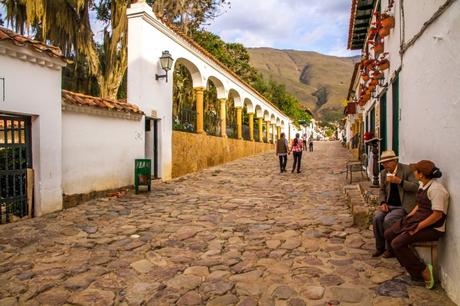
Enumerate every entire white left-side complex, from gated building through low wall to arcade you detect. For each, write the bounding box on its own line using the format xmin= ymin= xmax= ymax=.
xmin=0 ymin=1 xmax=300 ymax=223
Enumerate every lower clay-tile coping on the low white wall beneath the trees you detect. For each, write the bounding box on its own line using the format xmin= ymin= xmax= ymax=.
xmin=62 ymin=89 xmax=144 ymax=115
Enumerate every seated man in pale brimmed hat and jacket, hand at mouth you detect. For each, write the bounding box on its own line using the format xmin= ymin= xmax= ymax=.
xmin=372 ymin=150 xmax=418 ymax=258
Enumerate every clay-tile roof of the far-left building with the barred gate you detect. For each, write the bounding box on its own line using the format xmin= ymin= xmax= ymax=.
xmin=0 ymin=27 xmax=70 ymax=63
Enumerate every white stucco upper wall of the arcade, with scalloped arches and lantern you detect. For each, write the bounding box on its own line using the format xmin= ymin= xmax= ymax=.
xmin=128 ymin=3 xmax=290 ymax=179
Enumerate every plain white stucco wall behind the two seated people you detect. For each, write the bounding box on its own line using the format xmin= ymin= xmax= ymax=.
xmin=400 ymin=0 xmax=460 ymax=303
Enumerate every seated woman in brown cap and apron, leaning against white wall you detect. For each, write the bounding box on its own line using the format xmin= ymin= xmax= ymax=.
xmin=385 ymin=160 xmax=449 ymax=289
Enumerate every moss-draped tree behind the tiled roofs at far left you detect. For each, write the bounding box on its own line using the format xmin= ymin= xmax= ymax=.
xmin=1 ymin=0 xmax=128 ymax=98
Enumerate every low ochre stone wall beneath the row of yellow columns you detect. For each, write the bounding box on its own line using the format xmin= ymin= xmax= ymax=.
xmin=172 ymin=131 xmax=274 ymax=178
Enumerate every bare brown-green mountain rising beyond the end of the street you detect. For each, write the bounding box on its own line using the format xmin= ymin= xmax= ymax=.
xmin=248 ymin=48 xmax=359 ymax=121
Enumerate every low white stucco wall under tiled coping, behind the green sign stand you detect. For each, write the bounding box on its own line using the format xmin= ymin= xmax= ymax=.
xmin=62 ymin=111 xmax=145 ymax=195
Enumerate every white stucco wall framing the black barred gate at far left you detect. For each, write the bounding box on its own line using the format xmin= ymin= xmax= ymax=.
xmin=0 ymin=41 xmax=63 ymax=216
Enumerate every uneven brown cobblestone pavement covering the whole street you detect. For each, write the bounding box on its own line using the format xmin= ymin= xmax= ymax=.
xmin=0 ymin=143 xmax=453 ymax=306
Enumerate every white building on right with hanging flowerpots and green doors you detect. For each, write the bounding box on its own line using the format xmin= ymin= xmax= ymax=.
xmin=345 ymin=0 xmax=460 ymax=303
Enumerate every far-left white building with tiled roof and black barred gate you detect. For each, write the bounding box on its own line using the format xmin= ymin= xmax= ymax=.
xmin=0 ymin=28 xmax=67 ymax=219
